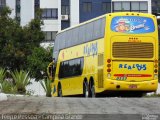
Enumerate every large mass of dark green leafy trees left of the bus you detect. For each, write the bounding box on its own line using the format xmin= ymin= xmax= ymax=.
xmin=0 ymin=7 xmax=51 ymax=79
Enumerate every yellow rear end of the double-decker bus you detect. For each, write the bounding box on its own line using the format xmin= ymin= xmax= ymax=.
xmin=104 ymin=12 xmax=158 ymax=93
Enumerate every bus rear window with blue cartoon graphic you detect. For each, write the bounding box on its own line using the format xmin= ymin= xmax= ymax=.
xmin=111 ymin=16 xmax=155 ymax=34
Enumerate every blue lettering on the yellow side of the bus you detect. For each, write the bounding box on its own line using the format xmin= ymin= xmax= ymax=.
xmin=83 ymin=42 xmax=98 ymax=57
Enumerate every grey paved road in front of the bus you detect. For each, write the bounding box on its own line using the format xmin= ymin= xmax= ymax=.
xmin=0 ymin=96 xmax=160 ymax=120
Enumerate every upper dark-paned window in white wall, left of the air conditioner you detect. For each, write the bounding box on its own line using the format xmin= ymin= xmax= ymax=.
xmin=42 ymin=9 xmax=58 ymax=19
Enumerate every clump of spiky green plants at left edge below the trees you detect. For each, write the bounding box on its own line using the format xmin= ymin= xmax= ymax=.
xmin=0 ymin=68 xmax=30 ymax=94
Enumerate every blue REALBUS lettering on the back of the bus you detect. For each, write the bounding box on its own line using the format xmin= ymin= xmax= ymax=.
xmin=119 ymin=64 xmax=147 ymax=71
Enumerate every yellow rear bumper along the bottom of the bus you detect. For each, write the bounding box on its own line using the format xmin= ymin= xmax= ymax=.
xmin=104 ymin=79 xmax=158 ymax=92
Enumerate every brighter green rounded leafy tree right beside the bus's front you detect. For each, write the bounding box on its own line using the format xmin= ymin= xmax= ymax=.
xmin=27 ymin=47 xmax=52 ymax=81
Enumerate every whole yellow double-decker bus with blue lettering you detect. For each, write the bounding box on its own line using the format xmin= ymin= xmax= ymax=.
xmin=48 ymin=12 xmax=158 ymax=97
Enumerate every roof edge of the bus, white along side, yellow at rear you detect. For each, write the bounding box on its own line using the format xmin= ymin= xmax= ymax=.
xmin=57 ymin=12 xmax=155 ymax=35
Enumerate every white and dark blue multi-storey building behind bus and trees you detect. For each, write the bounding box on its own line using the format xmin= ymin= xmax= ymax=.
xmin=0 ymin=0 xmax=152 ymax=43
